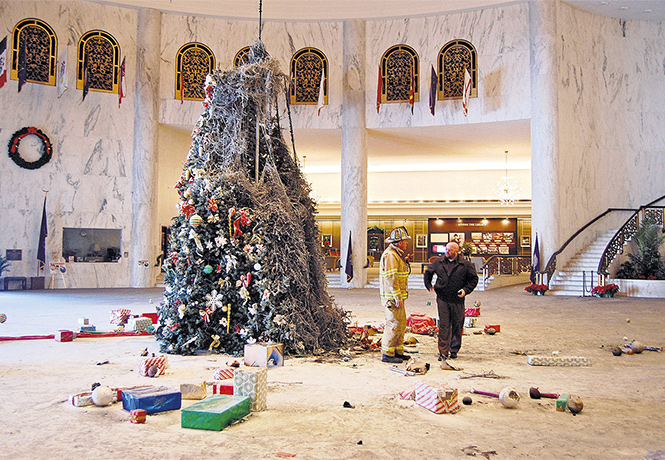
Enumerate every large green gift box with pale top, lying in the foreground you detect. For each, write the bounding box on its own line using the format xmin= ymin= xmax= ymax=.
xmin=180 ymin=395 xmax=250 ymax=431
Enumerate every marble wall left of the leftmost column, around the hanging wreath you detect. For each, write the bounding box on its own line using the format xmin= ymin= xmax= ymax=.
xmin=0 ymin=1 xmax=137 ymax=287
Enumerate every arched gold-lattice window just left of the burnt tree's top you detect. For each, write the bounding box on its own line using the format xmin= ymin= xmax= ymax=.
xmin=175 ymin=42 xmax=215 ymax=101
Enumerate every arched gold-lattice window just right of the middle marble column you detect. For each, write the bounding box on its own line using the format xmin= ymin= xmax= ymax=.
xmin=381 ymin=45 xmax=420 ymax=103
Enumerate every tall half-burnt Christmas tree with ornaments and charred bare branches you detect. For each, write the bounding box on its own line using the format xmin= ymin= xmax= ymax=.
xmin=155 ymin=40 xmax=347 ymax=354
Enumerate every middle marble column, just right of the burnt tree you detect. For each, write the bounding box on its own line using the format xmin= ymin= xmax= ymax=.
xmin=340 ymin=20 xmax=367 ymax=288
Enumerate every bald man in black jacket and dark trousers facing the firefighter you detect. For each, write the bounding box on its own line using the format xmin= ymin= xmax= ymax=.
xmin=424 ymin=242 xmax=478 ymax=370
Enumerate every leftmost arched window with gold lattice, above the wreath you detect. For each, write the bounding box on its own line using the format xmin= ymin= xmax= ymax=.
xmin=10 ymin=18 xmax=58 ymax=86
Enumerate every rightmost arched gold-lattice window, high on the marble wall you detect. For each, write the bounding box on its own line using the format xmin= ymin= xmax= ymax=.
xmin=438 ymin=40 xmax=478 ymax=100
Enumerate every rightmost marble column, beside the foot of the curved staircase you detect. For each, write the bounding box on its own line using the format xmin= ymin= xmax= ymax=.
xmin=529 ymin=0 xmax=563 ymax=278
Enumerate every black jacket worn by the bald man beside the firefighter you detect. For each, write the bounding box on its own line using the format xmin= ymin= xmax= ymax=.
xmin=424 ymin=255 xmax=478 ymax=303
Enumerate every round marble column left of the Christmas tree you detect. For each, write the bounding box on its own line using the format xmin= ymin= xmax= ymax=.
xmin=129 ymin=8 xmax=162 ymax=287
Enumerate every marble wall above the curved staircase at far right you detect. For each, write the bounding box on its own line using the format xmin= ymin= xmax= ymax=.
xmin=556 ymin=3 xmax=665 ymax=258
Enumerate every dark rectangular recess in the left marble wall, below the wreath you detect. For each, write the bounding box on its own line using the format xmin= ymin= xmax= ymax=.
xmin=62 ymin=227 xmax=122 ymax=262
